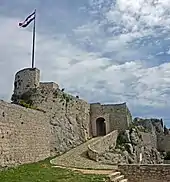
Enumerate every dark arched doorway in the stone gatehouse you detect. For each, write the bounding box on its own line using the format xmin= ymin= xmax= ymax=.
xmin=96 ymin=118 xmax=106 ymax=136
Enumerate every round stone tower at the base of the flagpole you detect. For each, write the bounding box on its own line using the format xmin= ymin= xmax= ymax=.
xmin=14 ymin=68 xmax=40 ymax=96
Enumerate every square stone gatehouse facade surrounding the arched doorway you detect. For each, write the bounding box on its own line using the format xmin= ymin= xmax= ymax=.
xmin=90 ymin=103 xmax=132 ymax=136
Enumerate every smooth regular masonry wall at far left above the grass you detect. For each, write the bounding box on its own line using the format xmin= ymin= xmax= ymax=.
xmin=0 ymin=101 xmax=51 ymax=167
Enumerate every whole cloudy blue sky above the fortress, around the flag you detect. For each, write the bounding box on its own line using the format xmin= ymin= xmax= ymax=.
xmin=0 ymin=0 xmax=170 ymax=127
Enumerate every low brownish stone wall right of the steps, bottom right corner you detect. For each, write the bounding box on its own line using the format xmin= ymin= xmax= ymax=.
xmin=118 ymin=164 xmax=170 ymax=182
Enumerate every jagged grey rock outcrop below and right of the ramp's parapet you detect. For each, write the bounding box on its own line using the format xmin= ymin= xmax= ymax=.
xmin=99 ymin=126 xmax=163 ymax=164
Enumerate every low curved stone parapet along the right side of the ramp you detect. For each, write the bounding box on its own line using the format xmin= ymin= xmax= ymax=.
xmin=88 ymin=130 xmax=118 ymax=161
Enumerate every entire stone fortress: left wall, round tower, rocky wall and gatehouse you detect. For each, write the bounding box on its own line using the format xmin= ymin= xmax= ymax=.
xmin=0 ymin=68 xmax=170 ymax=166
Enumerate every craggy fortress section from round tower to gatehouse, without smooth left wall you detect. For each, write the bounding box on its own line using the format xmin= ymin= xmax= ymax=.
xmin=9 ymin=68 xmax=131 ymax=155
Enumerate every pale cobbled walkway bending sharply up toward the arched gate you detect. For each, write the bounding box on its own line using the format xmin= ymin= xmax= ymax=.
xmin=51 ymin=137 xmax=117 ymax=170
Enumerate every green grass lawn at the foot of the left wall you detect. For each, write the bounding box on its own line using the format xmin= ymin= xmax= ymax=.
xmin=0 ymin=159 xmax=105 ymax=182
